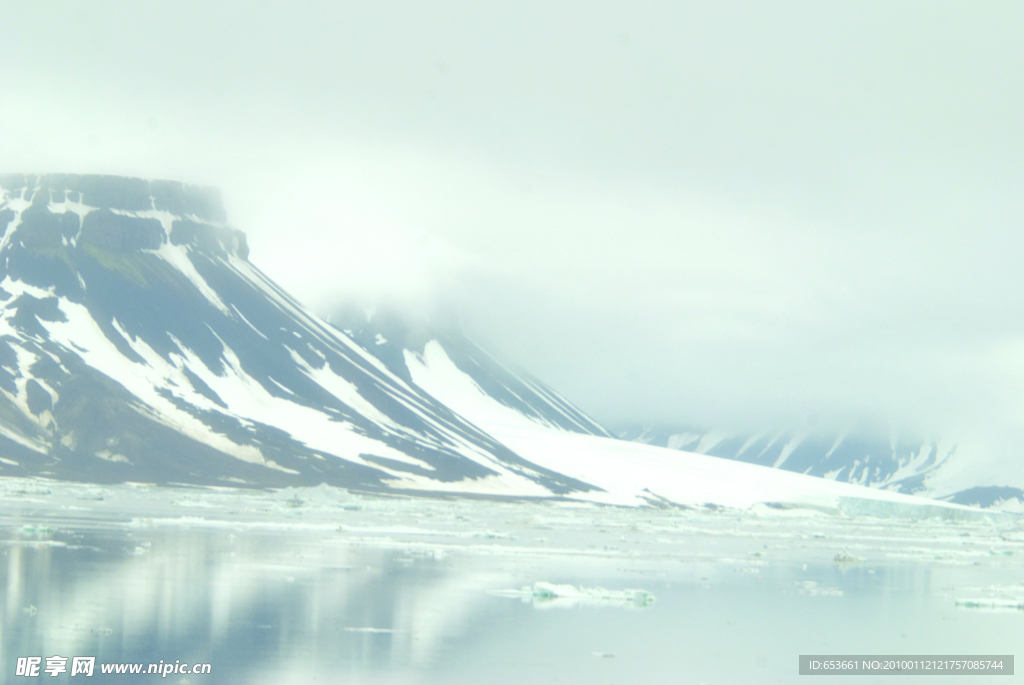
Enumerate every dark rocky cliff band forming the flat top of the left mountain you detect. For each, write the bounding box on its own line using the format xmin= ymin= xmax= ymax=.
xmin=0 ymin=174 xmax=249 ymax=259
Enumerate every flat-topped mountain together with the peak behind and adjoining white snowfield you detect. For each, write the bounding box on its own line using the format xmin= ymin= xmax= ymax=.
xmin=0 ymin=175 xmax=983 ymax=507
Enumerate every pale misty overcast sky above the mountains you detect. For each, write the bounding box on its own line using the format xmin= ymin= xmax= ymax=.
xmin=0 ymin=0 xmax=1024 ymax=452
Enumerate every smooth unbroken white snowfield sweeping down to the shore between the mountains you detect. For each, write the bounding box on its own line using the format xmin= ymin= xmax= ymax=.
xmin=406 ymin=341 xmax=975 ymax=515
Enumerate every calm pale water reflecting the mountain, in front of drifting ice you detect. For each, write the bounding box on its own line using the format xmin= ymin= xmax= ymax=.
xmin=0 ymin=483 xmax=1024 ymax=685
